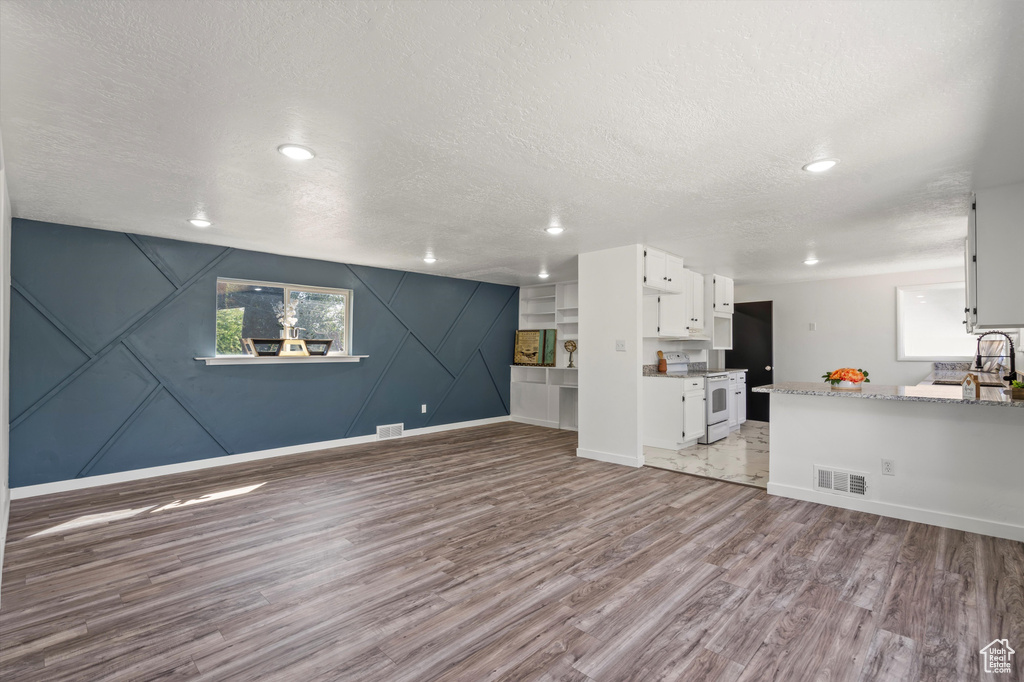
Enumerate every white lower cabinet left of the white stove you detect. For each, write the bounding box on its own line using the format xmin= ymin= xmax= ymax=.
xmin=643 ymin=377 xmax=705 ymax=450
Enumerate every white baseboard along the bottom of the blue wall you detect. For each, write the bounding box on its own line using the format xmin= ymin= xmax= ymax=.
xmin=10 ymin=416 xmax=509 ymax=500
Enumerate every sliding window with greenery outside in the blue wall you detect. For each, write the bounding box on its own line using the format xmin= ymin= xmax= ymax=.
xmin=217 ymin=279 xmax=352 ymax=355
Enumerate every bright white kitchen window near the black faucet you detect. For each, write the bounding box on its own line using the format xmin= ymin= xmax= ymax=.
xmin=896 ymin=282 xmax=978 ymax=361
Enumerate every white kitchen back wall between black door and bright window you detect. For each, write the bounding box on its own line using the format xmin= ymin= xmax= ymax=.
xmin=734 ymin=268 xmax=964 ymax=385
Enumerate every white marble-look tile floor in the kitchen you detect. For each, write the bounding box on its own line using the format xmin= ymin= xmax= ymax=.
xmin=643 ymin=420 xmax=768 ymax=488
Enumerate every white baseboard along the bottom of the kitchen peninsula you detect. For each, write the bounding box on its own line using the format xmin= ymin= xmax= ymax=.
xmin=768 ymin=482 xmax=1024 ymax=542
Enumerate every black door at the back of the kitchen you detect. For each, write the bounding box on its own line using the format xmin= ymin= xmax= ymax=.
xmin=725 ymin=301 xmax=775 ymax=422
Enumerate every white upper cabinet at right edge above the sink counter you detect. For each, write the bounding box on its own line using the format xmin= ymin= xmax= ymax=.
xmin=966 ymin=182 xmax=1024 ymax=331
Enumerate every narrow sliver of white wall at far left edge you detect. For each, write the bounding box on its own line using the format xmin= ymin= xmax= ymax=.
xmin=0 ymin=127 xmax=10 ymax=602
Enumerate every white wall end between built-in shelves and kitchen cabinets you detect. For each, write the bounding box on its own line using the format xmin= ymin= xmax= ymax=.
xmin=577 ymin=244 xmax=643 ymax=467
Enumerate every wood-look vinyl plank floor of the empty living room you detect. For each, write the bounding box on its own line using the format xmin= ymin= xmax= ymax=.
xmin=0 ymin=423 xmax=1024 ymax=682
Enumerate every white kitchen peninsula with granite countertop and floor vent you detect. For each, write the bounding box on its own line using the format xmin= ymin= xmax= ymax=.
xmin=753 ymin=383 xmax=1024 ymax=541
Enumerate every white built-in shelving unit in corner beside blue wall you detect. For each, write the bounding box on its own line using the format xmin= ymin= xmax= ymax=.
xmin=512 ymin=282 xmax=580 ymax=431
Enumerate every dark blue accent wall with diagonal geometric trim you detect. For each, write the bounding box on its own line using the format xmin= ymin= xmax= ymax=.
xmin=10 ymin=219 xmax=518 ymax=486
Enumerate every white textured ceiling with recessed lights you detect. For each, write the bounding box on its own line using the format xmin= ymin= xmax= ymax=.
xmin=0 ymin=0 xmax=1024 ymax=284
